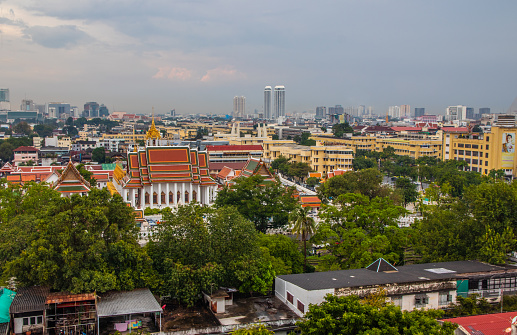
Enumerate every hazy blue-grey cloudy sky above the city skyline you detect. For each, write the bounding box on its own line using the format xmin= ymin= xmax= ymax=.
xmin=0 ymin=0 xmax=517 ymax=114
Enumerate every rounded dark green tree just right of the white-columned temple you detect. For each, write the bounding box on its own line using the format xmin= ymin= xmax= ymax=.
xmin=215 ymin=175 xmax=298 ymax=232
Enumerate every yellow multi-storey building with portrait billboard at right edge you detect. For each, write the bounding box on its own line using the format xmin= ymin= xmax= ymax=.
xmin=442 ymin=126 xmax=517 ymax=178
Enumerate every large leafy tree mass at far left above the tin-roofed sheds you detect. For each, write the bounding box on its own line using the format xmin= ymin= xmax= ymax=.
xmin=2 ymin=186 xmax=156 ymax=293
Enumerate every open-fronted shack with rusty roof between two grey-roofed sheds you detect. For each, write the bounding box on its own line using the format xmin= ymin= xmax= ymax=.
xmin=45 ymin=293 xmax=97 ymax=335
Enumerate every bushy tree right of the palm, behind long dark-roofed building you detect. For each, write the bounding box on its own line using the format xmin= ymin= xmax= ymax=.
xmin=312 ymin=193 xmax=406 ymax=270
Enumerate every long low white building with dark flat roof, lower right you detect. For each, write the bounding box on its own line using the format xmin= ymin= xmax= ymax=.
xmin=275 ymin=258 xmax=517 ymax=316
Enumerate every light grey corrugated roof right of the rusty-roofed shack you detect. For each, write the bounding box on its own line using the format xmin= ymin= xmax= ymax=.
xmin=97 ymin=288 xmax=162 ymax=317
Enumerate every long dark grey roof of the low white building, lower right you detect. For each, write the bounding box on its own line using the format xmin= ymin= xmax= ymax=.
xmin=278 ymin=261 xmax=508 ymax=291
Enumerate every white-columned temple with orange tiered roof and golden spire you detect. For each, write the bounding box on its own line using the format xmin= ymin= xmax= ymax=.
xmin=108 ymin=119 xmax=217 ymax=209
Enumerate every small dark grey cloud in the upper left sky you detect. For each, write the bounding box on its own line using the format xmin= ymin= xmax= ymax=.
xmin=25 ymin=25 xmax=90 ymax=49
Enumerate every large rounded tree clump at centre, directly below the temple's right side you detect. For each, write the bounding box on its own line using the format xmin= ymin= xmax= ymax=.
xmin=147 ymin=204 xmax=275 ymax=306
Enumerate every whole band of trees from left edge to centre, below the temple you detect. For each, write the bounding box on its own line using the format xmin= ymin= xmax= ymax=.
xmin=0 ymin=183 xmax=303 ymax=305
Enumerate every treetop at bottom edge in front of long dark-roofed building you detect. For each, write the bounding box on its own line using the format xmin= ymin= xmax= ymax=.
xmin=297 ymin=294 xmax=456 ymax=335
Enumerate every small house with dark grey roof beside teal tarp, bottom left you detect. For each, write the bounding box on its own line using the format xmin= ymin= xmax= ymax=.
xmin=9 ymin=286 xmax=49 ymax=335
